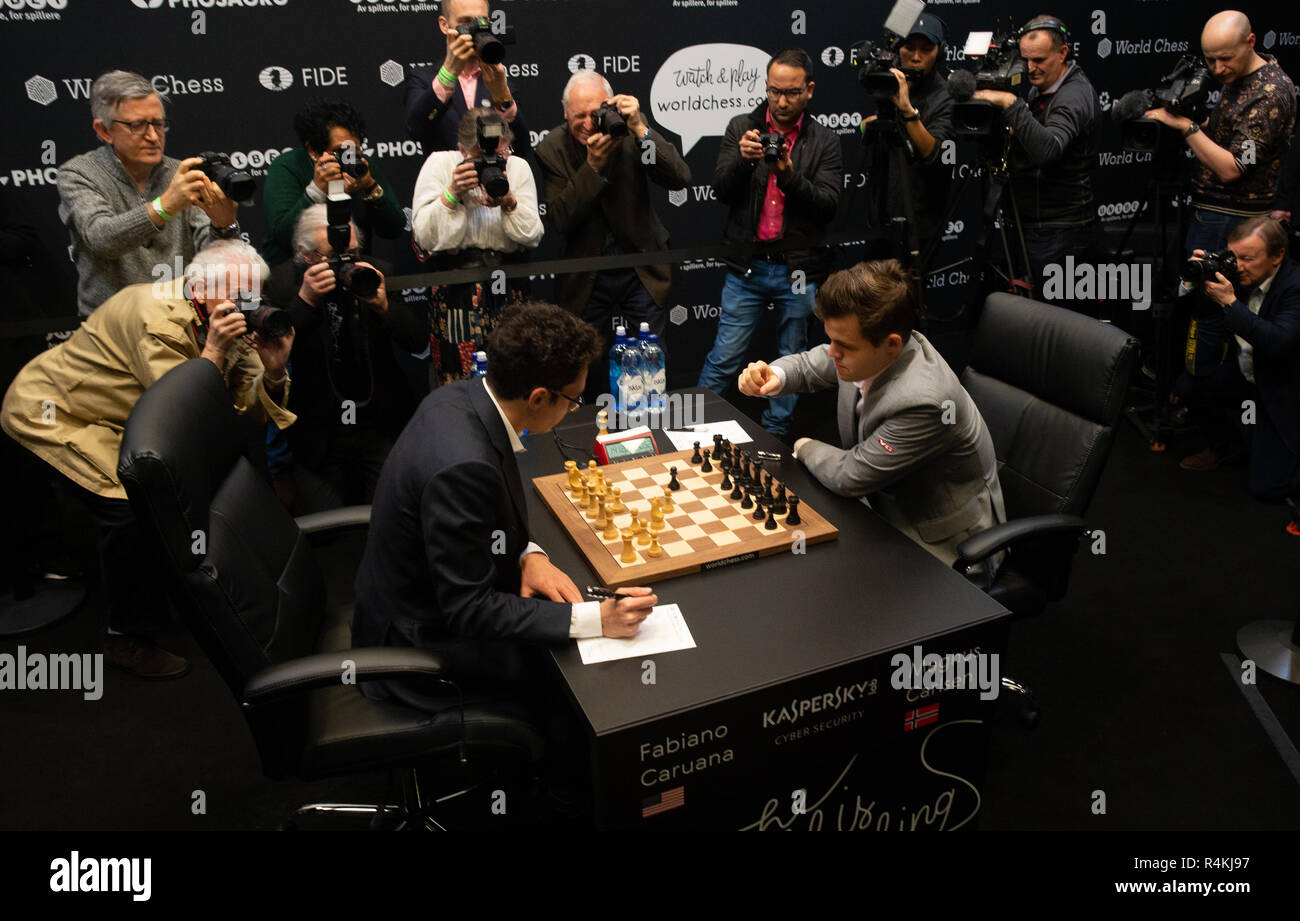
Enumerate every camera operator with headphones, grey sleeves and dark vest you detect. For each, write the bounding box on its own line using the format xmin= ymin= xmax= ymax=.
xmin=972 ymin=16 xmax=1099 ymax=299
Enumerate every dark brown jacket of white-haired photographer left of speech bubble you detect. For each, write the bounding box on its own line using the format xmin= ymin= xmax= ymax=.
xmin=537 ymin=125 xmax=690 ymax=316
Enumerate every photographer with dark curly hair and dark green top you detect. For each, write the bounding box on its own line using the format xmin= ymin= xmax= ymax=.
xmin=261 ymin=99 xmax=406 ymax=268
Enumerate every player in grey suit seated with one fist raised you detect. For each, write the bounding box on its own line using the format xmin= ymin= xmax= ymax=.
xmin=740 ymin=259 xmax=1006 ymax=565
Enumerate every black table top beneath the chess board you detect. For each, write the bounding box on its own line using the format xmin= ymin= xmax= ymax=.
xmin=519 ymin=389 xmax=1009 ymax=735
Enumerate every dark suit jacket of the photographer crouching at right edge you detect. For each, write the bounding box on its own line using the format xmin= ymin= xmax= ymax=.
xmin=1223 ymin=259 xmax=1300 ymax=455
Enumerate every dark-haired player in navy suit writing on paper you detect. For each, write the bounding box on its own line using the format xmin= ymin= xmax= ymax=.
xmin=352 ymin=303 xmax=657 ymax=710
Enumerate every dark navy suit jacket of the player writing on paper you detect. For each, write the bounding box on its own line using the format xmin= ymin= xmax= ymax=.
xmin=352 ymin=379 xmax=572 ymax=696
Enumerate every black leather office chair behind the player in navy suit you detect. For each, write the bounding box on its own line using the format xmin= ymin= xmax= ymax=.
xmin=118 ymin=359 xmax=542 ymax=827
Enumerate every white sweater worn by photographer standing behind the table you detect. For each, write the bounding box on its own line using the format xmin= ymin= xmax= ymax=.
xmin=411 ymin=151 xmax=542 ymax=252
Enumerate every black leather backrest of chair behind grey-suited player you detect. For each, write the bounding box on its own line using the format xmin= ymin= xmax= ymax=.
xmin=962 ymin=293 xmax=1138 ymax=518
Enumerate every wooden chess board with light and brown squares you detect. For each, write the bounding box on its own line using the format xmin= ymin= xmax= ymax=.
xmin=533 ymin=450 xmax=840 ymax=588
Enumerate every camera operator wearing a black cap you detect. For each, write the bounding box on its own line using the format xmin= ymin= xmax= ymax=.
xmin=863 ymin=16 xmax=953 ymax=266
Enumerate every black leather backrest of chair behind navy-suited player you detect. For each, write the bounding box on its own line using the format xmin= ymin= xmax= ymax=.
xmin=117 ymin=358 xmax=325 ymax=699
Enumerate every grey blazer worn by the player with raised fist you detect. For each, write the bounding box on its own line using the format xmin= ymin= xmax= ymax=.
xmin=772 ymin=332 xmax=1006 ymax=565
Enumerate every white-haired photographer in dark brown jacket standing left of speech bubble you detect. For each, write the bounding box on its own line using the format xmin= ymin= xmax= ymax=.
xmin=537 ymin=70 xmax=690 ymax=394
